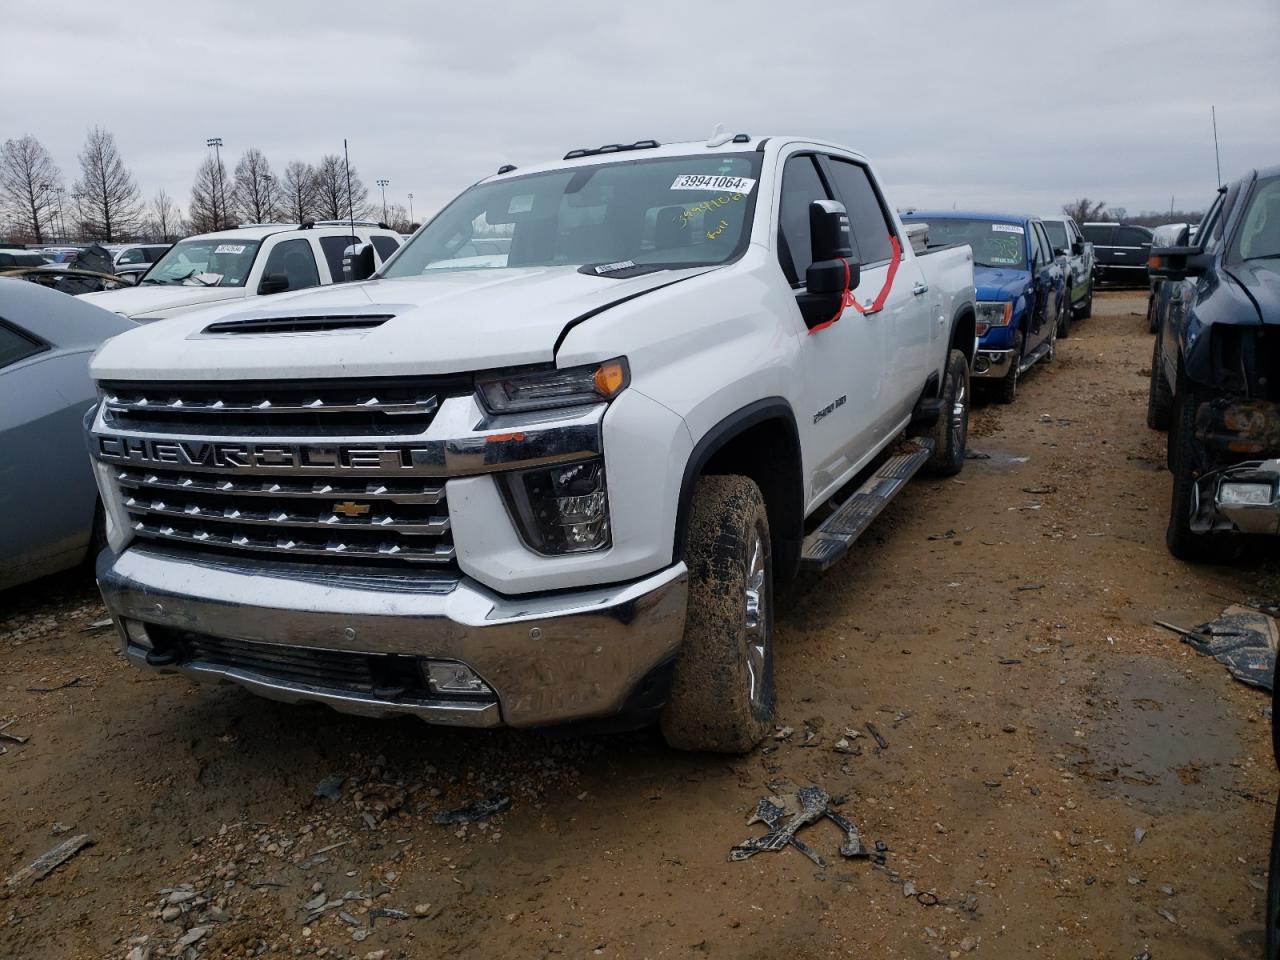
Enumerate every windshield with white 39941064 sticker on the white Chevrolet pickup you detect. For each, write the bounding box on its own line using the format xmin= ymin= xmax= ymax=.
xmin=381 ymin=152 xmax=760 ymax=276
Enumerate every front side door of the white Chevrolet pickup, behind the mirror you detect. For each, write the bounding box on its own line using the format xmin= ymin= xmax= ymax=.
xmin=777 ymin=152 xmax=886 ymax=503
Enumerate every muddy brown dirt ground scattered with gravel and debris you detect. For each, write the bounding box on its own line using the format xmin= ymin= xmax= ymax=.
xmin=0 ymin=293 xmax=1280 ymax=960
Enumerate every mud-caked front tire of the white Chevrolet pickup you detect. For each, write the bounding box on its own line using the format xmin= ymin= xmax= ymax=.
xmin=660 ymin=476 xmax=774 ymax=754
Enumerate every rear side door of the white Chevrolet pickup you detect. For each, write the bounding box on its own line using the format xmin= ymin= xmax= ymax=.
xmin=819 ymin=155 xmax=937 ymax=440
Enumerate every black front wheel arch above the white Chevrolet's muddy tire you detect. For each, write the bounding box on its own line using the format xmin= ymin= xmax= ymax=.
xmin=672 ymin=397 xmax=804 ymax=580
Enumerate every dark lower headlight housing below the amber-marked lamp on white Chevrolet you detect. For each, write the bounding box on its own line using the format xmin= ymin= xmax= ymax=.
xmin=499 ymin=460 xmax=612 ymax=554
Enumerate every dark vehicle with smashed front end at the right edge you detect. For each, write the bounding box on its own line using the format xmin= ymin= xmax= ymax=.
xmin=1147 ymin=166 xmax=1280 ymax=561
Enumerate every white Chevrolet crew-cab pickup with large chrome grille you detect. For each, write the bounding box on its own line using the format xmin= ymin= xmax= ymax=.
xmin=86 ymin=134 xmax=974 ymax=751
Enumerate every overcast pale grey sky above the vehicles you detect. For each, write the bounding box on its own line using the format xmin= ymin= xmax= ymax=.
xmin=0 ymin=0 xmax=1280 ymax=219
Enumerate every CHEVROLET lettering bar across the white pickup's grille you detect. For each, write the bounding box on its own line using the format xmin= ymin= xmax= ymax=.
xmin=95 ymin=435 xmax=431 ymax=471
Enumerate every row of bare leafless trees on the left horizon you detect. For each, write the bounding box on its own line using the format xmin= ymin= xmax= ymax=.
xmin=0 ymin=127 xmax=412 ymax=243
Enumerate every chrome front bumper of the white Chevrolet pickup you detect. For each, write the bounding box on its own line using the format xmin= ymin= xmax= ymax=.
xmin=97 ymin=544 xmax=687 ymax=727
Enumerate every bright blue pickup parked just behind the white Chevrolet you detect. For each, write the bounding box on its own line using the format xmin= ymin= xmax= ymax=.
xmin=902 ymin=210 xmax=1070 ymax=403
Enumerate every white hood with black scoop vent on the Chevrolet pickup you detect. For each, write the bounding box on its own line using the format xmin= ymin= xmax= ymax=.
xmin=92 ymin=266 xmax=716 ymax=380
